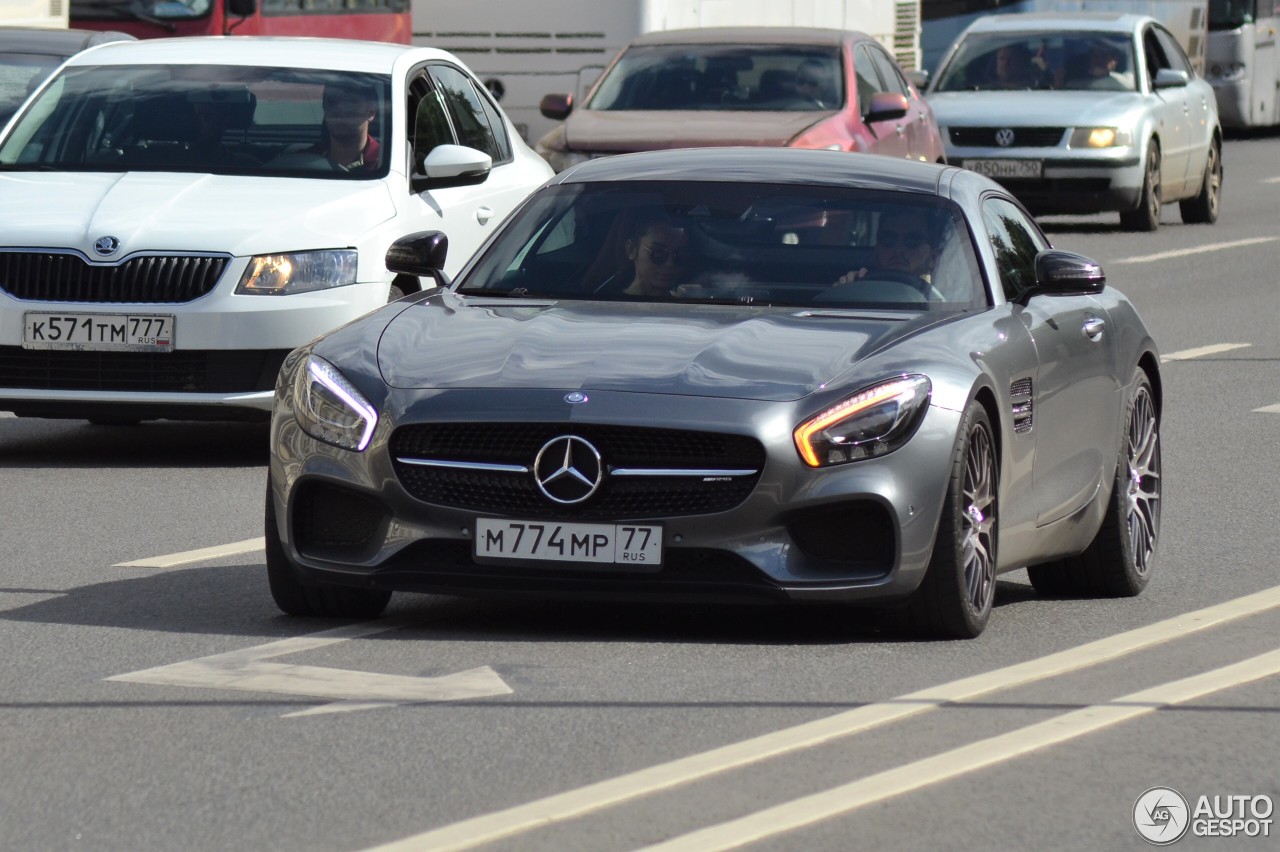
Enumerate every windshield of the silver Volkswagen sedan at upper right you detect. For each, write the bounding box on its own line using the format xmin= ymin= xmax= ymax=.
xmin=931 ymin=32 xmax=1138 ymax=92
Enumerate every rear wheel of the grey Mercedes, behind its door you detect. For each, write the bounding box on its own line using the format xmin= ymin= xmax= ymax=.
xmin=1027 ymin=372 xmax=1161 ymax=597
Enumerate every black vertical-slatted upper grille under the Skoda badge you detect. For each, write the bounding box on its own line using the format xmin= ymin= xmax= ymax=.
xmin=0 ymin=251 xmax=229 ymax=304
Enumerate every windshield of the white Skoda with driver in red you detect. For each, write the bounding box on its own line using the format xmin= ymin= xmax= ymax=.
xmin=0 ymin=65 xmax=390 ymax=179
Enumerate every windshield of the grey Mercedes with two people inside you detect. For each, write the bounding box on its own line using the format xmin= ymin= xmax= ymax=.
xmin=456 ymin=180 xmax=986 ymax=311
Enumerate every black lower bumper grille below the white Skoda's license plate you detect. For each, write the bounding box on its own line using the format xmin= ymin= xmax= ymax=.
xmin=0 ymin=347 xmax=288 ymax=393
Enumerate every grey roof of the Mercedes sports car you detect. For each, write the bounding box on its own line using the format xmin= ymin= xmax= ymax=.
xmin=552 ymin=147 xmax=960 ymax=194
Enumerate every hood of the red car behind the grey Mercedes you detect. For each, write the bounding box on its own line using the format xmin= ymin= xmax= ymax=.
xmin=564 ymin=110 xmax=831 ymax=154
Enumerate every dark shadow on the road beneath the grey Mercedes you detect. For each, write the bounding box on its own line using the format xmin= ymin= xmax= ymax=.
xmin=0 ymin=563 xmax=1039 ymax=645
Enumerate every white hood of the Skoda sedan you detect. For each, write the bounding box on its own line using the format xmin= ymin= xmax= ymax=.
xmin=0 ymin=171 xmax=396 ymax=257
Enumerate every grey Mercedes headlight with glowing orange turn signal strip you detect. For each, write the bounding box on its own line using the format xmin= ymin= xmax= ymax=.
xmin=794 ymin=375 xmax=933 ymax=467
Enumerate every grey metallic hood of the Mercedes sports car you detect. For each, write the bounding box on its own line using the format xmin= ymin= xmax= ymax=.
xmin=378 ymin=293 xmax=940 ymax=400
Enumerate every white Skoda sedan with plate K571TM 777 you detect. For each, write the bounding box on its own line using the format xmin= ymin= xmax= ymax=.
xmin=0 ymin=37 xmax=552 ymax=422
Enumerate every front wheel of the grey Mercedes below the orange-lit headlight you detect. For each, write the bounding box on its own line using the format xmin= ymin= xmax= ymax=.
xmin=908 ymin=400 xmax=998 ymax=638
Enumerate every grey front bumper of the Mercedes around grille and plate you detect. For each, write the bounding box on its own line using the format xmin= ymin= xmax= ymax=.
xmin=270 ymin=389 xmax=959 ymax=601
